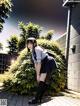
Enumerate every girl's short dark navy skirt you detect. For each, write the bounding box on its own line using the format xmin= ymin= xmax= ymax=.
xmin=40 ymin=56 xmax=56 ymax=74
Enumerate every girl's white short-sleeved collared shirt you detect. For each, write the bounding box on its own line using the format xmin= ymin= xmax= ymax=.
xmin=32 ymin=46 xmax=48 ymax=63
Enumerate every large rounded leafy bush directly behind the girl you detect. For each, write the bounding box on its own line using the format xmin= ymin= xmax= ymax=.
xmin=4 ymin=39 xmax=66 ymax=95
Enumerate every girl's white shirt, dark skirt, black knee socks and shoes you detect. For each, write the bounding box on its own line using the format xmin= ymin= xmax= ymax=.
xmin=29 ymin=46 xmax=55 ymax=104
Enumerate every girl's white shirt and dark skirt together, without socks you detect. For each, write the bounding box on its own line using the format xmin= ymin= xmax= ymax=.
xmin=32 ymin=46 xmax=56 ymax=73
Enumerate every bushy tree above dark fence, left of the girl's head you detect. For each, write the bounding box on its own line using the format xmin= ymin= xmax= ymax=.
xmin=8 ymin=35 xmax=18 ymax=55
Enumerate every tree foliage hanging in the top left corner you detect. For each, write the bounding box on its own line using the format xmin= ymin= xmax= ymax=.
xmin=0 ymin=0 xmax=12 ymax=32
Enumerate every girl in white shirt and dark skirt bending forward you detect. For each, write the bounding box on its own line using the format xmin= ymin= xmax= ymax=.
xmin=27 ymin=37 xmax=56 ymax=104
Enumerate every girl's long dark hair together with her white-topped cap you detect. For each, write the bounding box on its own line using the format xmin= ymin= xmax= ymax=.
xmin=27 ymin=37 xmax=37 ymax=60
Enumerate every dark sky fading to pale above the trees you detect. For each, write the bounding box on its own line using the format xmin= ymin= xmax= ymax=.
xmin=0 ymin=0 xmax=67 ymax=51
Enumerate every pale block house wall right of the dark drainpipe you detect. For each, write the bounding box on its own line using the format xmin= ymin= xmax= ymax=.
xmin=68 ymin=4 xmax=80 ymax=92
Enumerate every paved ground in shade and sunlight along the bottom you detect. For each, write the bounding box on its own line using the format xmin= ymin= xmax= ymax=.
xmin=0 ymin=92 xmax=80 ymax=106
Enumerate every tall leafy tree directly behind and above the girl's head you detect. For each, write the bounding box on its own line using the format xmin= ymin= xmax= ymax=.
xmin=18 ymin=22 xmax=41 ymax=51
